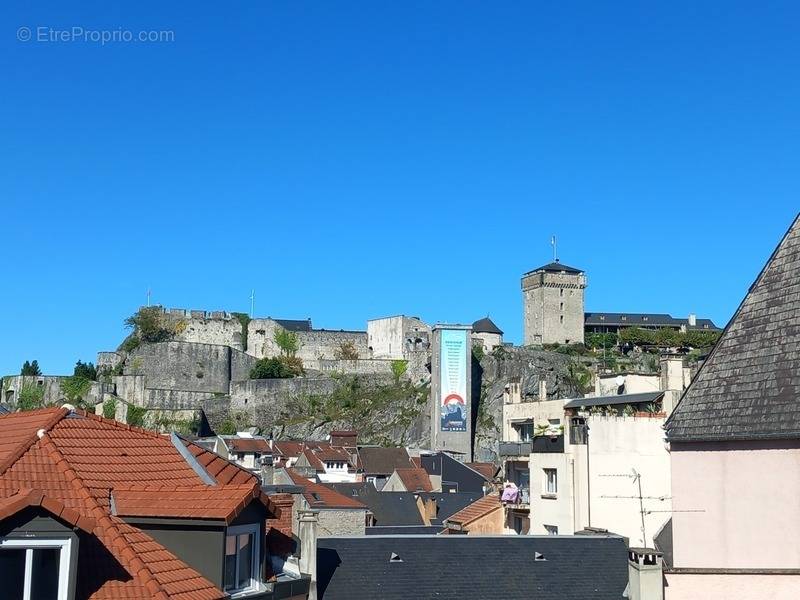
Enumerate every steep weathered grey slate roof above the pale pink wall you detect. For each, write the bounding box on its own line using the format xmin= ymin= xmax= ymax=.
xmin=665 ymin=216 xmax=800 ymax=442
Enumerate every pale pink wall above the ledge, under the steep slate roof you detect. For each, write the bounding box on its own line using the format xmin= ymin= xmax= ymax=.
xmin=671 ymin=440 xmax=800 ymax=572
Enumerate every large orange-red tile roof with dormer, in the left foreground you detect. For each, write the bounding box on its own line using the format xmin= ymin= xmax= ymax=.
xmin=0 ymin=408 xmax=278 ymax=600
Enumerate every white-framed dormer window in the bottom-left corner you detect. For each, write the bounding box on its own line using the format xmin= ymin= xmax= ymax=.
xmin=0 ymin=538 xmax=74 ymax=600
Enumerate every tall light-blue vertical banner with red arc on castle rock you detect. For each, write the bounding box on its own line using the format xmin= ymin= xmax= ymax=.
xmin=439 ymin=329 xmax=469 ymax=431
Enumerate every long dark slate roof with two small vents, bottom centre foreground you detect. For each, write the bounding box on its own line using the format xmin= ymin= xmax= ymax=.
xmin=317 ymin=535 xmax=628 ymax=600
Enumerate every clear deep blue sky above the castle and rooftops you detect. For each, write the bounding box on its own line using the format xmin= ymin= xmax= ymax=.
xmin=0 ymin=0 xmax=800 ymax=373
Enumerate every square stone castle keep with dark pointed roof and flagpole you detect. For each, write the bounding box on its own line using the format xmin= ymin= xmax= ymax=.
xmin=522 ymin=260 xmax=586 ymax=346
